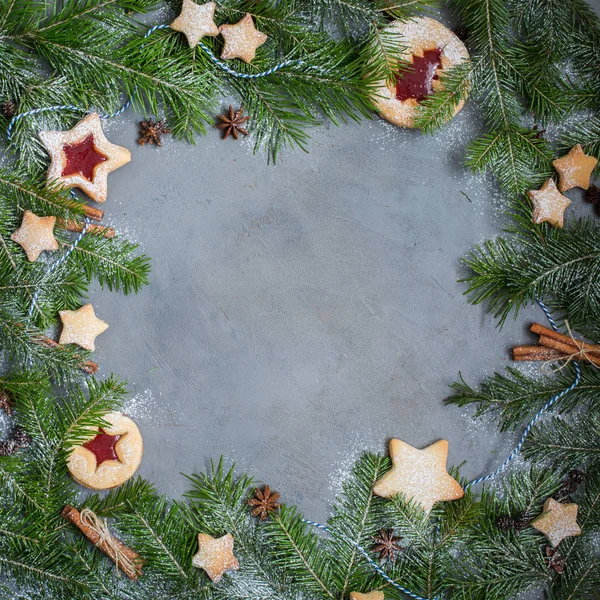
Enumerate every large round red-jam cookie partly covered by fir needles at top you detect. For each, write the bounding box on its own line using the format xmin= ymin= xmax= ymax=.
xmin=374 ymin=17 xmax=469 ymax=127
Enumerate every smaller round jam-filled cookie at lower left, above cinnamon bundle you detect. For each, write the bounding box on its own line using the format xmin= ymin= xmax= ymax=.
xmin=67 ymin=412 xmax=144 ymax=490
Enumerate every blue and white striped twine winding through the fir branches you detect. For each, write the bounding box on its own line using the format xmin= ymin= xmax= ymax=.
xmin=6 ymin=24 xmax=581 ymax=600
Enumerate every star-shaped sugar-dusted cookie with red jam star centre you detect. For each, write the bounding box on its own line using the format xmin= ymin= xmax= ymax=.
xmin=39 ymin=113 xmax=131 ymax=202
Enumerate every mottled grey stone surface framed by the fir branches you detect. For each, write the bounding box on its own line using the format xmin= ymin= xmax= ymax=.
xmin=21 ymin=0 xmax=600 ymax=520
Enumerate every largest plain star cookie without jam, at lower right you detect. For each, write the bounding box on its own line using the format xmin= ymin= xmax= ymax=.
xmin=373 ymin=440 xmax=465 ymax=513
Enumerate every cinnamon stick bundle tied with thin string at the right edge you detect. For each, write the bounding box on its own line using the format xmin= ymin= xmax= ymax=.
xmin=513 ymin=323 xmax=600 ymax=367
